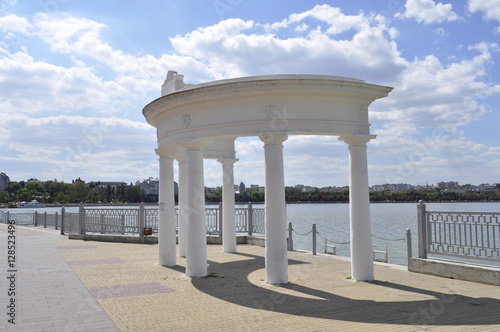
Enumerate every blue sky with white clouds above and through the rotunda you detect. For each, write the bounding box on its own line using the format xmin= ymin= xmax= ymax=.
xmin=0 ymin=0 xmax=500 ymax=187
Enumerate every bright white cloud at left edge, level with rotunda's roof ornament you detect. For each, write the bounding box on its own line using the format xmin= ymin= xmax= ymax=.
xmin=0 ymin=52 xmax=126 ymax=114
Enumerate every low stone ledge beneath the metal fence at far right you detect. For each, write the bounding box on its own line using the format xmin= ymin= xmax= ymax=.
xmin=408 ymin=258 xmax=500 ymax=286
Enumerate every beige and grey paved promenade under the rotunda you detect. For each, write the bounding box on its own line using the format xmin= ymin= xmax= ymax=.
xmin=0 ymin=225 xmax=500 ymax=331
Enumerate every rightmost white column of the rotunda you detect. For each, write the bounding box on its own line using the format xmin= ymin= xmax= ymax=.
xmin=339 ymin=135 xmax=375 ymax=281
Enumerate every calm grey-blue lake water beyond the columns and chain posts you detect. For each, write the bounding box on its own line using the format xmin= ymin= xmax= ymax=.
xmin=2 ymin=202 xmax=500 ymax=265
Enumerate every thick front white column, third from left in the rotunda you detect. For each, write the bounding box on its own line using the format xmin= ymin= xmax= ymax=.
xmin=183 ymin=140 xmax=207 ymax=277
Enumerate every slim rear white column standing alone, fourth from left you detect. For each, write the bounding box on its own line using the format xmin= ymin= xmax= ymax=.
xmin=217 ymin=158 xmax=238 ymax=252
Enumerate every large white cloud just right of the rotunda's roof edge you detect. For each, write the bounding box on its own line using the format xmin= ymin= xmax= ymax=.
xmin=371 ymin=44 xmax=500 ymax=130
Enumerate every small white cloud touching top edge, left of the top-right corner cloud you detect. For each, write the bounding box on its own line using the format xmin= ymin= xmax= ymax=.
xmin=395 ymin=0 xmax=460 ymax=24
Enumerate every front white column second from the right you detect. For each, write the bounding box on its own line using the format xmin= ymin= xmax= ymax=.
xmin=260 ymin=134 xmax=288 ymax=284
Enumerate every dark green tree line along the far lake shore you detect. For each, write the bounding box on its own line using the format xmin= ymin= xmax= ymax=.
xmin=0 ymin=180 xmax=500 ymax=204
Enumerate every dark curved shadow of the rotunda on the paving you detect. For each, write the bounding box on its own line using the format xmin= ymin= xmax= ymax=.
xmin=187 ymin=253 xmax=500 ymax=326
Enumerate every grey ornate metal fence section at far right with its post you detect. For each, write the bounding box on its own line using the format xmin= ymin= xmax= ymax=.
xmin=418 ymin=203 xmax=500 ymax=261
